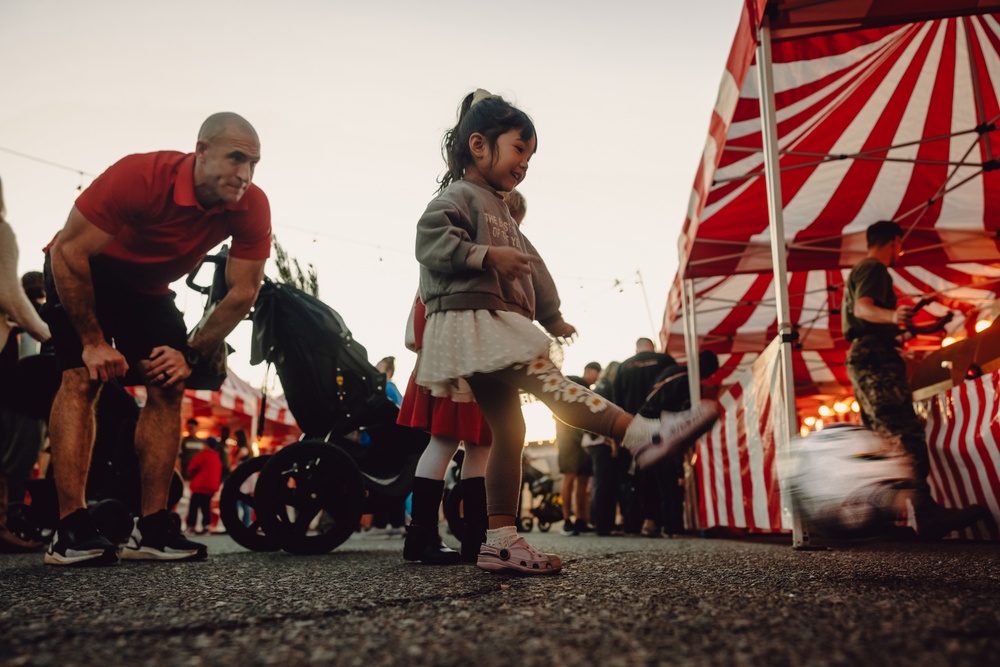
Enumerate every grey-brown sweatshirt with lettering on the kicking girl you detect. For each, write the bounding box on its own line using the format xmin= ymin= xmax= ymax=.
xmin=416 ymin=181 xmax=562 ymax=326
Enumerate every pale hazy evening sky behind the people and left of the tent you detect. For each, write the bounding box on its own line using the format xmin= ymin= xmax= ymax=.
xmin=0 ymin=0 xmax=742 ymax=440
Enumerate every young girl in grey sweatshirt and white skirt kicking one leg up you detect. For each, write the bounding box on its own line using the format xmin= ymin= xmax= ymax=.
xmin=416 ymin=90 xmax=720 ymax=574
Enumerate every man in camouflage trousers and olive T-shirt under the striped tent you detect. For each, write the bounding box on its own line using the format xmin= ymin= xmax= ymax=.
xmin=841 ymin=220 xmax=984 ymax=540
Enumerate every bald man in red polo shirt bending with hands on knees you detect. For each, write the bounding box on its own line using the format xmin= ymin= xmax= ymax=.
xmin=43 ymin=112 xmax=271 ymax=565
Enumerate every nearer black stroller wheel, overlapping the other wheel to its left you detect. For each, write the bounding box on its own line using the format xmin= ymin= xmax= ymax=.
xmin=255 ymin=440 xmax=365 ymax=554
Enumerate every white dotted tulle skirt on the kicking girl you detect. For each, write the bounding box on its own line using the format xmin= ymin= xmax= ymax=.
xmin=416 ymin=310 xmax=551 ymax=402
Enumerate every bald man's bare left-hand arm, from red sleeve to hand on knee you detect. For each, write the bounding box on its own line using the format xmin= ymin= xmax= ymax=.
xmin=49 ymin=211 xmax=128 ymax=382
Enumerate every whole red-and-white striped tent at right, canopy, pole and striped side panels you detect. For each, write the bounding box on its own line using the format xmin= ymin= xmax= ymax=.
xmin=661 ymin=0 xmax=1000 ymax=544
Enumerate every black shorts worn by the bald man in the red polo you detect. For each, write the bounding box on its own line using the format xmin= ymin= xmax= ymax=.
xmin=42 ymin=256 xmax=187 ymax=385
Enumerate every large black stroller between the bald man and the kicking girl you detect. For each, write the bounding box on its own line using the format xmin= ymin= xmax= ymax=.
xmin=220 ymin=279 xmax=428 ymax=554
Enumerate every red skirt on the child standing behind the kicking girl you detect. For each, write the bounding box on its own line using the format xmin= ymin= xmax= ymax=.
xmin=396 ymin=375 xmax=493 ymax=446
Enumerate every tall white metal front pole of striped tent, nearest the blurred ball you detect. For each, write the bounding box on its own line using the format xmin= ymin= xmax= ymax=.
xmin=756 ymin=14 xmax=809 ymax=548
